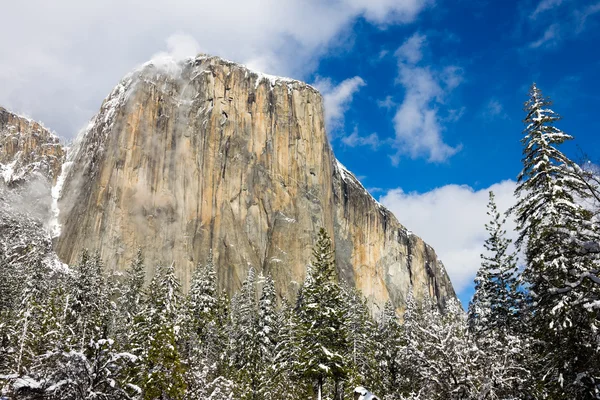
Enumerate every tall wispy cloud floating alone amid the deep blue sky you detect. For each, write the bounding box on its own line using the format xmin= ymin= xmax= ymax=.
xmin=392 ymin=33 xmax=462 ymax=164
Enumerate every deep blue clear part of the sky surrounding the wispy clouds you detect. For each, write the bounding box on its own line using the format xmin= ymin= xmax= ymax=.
xmin=316 ymin=0 xmax=600 ymax=192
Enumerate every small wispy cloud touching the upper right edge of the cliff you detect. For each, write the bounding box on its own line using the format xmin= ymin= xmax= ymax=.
xmin=313 ymin=76 xmax=365 ymax=137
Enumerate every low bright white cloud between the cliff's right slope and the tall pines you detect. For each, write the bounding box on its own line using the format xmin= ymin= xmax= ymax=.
xmin=379 ymin=180 xmax=516 ymax=293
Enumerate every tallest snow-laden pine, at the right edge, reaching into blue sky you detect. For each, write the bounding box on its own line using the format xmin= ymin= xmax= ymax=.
xmin=513 ymin=84 xmax=600 ymax=398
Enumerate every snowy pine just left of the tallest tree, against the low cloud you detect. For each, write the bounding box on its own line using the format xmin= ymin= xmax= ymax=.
xmin=468 ymin=191 xmax=532 ymax=398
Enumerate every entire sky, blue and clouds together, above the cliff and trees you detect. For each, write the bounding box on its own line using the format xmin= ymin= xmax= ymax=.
xmin=0 ymin=0 xmax=600 ymax=303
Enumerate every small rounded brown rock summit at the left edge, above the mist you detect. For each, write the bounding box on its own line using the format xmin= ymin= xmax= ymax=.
xmin=0 ymin=107 xmax=65 ymax=185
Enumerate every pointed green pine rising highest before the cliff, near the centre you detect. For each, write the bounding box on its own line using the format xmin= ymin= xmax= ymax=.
xmin=299 ymin=228 xmax=348 ymax=400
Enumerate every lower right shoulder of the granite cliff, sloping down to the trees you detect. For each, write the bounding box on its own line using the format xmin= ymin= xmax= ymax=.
xmin=333 ymin=161 xmax=456 ymax=308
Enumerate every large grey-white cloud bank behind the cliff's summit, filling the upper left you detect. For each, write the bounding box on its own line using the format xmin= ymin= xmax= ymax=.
xmin=0 ymin=0 xmax=430 ymax=137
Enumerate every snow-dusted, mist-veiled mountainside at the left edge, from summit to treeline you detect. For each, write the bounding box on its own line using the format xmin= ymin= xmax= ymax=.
xmin=0 ymin=107 xmax=65 ymax=276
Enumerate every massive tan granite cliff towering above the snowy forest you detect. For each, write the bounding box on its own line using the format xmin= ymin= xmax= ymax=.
xmin=56 ymin=56 xmax=454 ymax=308
